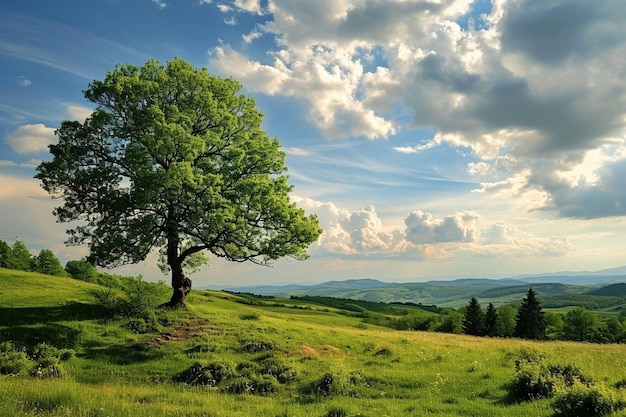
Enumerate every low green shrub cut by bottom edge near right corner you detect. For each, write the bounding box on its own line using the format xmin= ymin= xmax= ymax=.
xmin=552 ymin=383 xmax=623 ymax=417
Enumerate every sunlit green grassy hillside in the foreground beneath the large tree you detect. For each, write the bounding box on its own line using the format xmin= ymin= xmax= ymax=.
xmin=0 ymin=270 xmax=626 ymax=417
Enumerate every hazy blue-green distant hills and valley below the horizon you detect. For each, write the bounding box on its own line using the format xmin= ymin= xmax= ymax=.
xmin=211 ymin=267 xmax=626 ymax=308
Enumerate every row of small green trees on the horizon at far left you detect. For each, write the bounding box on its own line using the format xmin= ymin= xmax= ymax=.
xmin=0 ymin=240 xmax=97 ymax=281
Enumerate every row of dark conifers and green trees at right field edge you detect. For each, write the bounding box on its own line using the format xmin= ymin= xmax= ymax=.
xmin=461 ymin=288 xmax=626 ymax=343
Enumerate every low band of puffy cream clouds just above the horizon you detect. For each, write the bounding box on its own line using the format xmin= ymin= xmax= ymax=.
xmin=294 ymin=197 xmax=576 ymax=260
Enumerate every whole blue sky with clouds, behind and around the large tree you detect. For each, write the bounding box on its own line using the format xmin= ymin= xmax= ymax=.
xmin=0 ymin=0 xmax=626 ymax=287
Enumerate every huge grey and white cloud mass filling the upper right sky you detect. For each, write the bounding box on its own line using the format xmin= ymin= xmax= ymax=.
xmin=210 ymin=0 xmax=626 ymax=217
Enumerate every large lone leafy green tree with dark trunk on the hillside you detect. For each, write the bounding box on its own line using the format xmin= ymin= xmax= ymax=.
xmin=36 ymin=59 xmax=321 ymax=307
